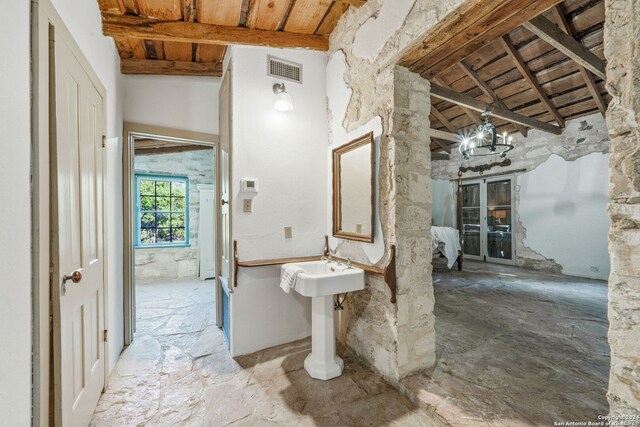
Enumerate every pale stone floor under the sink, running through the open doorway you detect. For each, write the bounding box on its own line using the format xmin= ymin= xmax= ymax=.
xmin=91 ymin=279 xmax=432 ymax=427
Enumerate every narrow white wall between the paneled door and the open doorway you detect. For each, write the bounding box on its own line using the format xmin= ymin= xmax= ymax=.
xmin=52 ymin=0 xmax=124 ymax=371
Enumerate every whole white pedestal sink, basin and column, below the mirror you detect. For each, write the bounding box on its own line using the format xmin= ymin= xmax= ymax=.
xmin=283 ymin=261 xmax=364 ymax=380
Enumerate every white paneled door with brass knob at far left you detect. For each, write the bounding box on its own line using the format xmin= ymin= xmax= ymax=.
xmin=51 ymin=27 xmax=105 ymax=427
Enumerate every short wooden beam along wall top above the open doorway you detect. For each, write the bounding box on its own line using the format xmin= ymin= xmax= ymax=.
xmin=120 ymin=58 xmax=222 ymax=77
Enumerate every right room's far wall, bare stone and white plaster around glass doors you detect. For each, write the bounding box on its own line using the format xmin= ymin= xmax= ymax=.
xmin=432 ymin=114 xmax=609 ymax=279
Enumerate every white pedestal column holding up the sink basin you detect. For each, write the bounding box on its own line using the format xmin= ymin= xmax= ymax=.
xmin=304 ymin=295 xmax=344 ymax=380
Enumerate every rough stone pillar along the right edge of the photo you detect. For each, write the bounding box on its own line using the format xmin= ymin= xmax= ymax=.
xmin=604 ymin=0 xmax=640 ymax=416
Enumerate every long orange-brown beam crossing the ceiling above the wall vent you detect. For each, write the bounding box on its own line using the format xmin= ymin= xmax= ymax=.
xmin=102 ymin=13 xmax=329 ymax=51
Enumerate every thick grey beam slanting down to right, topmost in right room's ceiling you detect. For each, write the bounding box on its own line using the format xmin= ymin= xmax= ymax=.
xmin=523 ymin=16 xmax=607 ymax=80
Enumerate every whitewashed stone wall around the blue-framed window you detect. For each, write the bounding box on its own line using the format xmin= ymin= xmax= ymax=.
xmin=135 ymin=149 xmax=214 ymax=281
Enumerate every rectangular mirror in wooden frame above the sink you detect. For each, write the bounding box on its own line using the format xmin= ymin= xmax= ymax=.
xmin=333 ymin=132 xmax=375 ymax=243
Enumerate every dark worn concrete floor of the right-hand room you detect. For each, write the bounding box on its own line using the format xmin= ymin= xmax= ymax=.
xmin=403 ymin=260 xmax=609 ymax=427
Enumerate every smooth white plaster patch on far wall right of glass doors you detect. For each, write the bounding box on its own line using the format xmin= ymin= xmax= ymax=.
xmin=517 ymin=153 xmax=610 ymax=280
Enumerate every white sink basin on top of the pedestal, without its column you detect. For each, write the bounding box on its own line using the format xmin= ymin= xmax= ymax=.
xmin=294 ymin=261 xmax=364 ymax=297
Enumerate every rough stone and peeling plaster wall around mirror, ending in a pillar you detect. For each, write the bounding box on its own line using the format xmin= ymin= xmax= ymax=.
xmin=327 ymin=0 xmax=464 ymax=380
